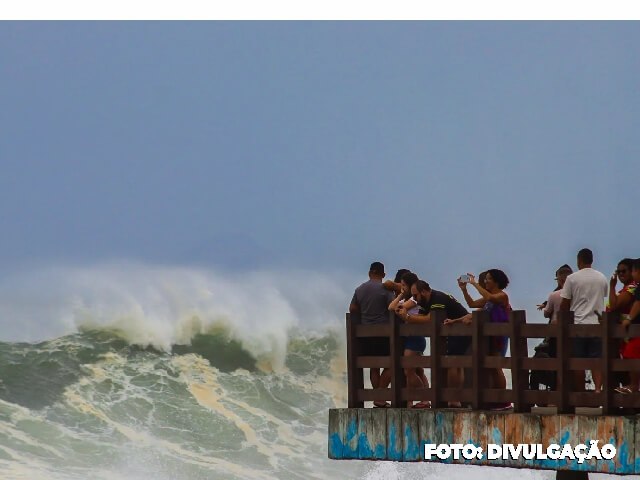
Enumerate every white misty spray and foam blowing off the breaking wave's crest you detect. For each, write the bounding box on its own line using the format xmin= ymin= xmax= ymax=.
xmin=0 ymin=262 xmax=354 ymax=369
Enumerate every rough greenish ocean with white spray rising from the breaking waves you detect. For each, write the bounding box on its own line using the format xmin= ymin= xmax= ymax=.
xmin=0 ymin=263 xmax=603 ymax=480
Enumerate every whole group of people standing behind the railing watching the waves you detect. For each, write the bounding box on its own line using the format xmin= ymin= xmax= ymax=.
xmin=349 ymin=248 xmax=640 ymax=410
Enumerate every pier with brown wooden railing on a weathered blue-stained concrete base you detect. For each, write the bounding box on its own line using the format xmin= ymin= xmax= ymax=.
xmin=328 ymin=311 xmax=640 ymax=478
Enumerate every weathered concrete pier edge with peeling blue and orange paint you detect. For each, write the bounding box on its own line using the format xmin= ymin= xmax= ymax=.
xmin=328 ymin=408 xmax=640 ymax=475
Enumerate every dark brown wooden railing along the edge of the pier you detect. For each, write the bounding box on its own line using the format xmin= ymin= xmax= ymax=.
xmin=347 ymin=310 xmax=640 ymax=414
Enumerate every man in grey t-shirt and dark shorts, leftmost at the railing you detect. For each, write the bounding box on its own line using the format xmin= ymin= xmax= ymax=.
xmin=349 ymin=262 xmax=394 ymax=400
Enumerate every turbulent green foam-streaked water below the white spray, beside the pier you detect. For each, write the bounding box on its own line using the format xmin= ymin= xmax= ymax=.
xmin=0 ymin=331 xmax=362 ymax=479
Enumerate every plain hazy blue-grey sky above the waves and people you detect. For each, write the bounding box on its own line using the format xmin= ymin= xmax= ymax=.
xmin=0 ymin=21 xmax=640 ymax=314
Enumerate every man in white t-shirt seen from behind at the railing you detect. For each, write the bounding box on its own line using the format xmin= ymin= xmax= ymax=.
xmin=560 ymin=248 xmax=608 ymax=392
